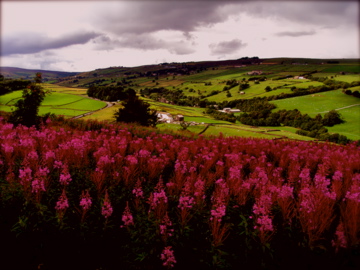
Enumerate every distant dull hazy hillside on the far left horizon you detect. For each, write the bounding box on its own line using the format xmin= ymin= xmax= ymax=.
xmin=0 ymin=67 xmax=78 ymax=81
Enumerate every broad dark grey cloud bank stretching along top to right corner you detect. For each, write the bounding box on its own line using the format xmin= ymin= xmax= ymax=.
xmin=94 ymin=0 xmax=358 ymax=38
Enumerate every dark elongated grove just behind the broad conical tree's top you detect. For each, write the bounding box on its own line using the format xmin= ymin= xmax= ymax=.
xmin=86 ymin=85 xmax=135 ymax=101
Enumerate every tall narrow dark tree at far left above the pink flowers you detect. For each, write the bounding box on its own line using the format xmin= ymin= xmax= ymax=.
xmin=9 ymin=72 xmax=46 ymax=127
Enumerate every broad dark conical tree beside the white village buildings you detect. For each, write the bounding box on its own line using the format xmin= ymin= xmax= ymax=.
xmin=114 ymin=91 xmax=157 ymax=126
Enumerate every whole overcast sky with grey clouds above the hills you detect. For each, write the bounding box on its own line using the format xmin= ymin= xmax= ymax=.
xmin=0 ymin=0 xmax=360 ymax=71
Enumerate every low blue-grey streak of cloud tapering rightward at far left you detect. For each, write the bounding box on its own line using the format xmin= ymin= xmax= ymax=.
xmin=1 ymin=32 xmax=100 ymax=56
